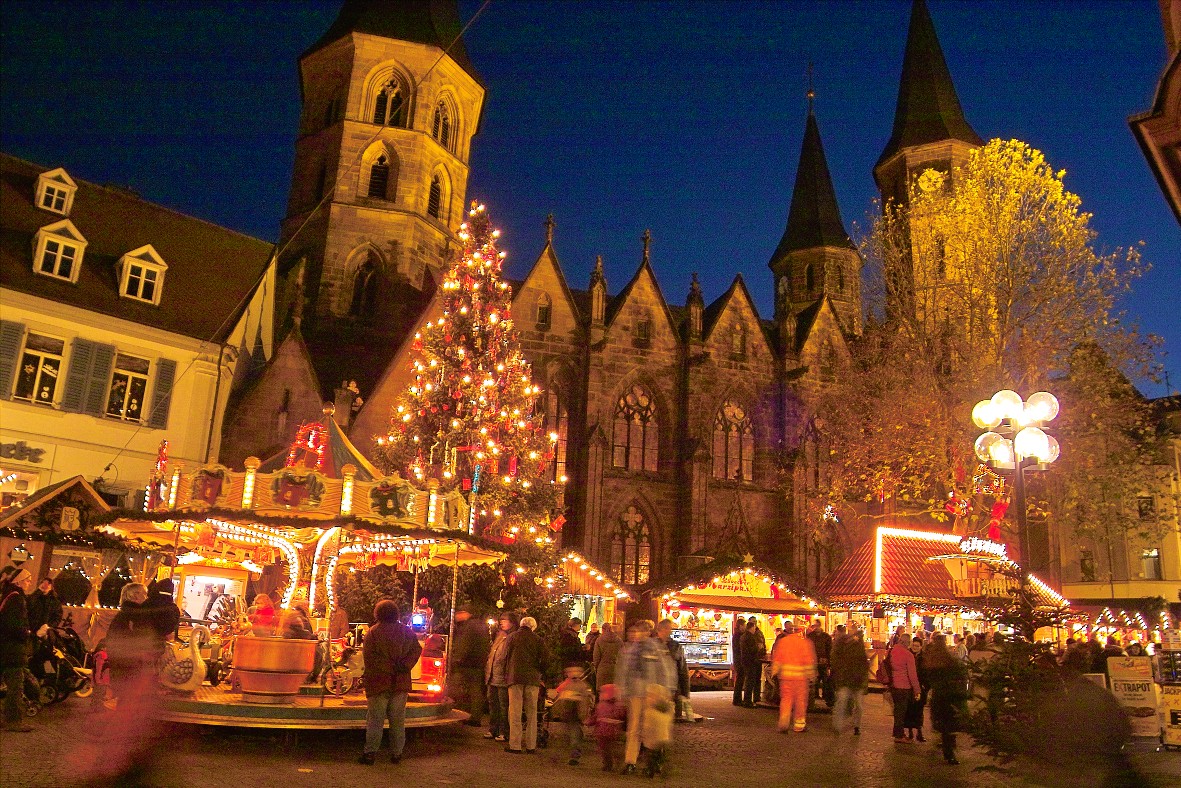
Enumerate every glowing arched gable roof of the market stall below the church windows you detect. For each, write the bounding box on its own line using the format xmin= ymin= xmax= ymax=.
xmin=653 ymin=555 xmax=827 ymax=614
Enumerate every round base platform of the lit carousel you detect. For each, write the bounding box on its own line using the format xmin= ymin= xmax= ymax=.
xmin=156 ymin=685 xmax=469 ymax=730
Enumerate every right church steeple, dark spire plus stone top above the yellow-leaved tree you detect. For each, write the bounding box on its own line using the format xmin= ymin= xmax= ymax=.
xmin=874 ymin=0 xmax=984 ymax=202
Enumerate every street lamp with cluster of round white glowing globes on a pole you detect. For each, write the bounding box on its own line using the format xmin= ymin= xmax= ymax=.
xmin=972 ymin=389 xmax=1059 ymax=571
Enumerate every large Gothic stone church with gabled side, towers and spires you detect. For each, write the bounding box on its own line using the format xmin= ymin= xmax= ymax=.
xmin=221 ymin=0 xmax=979 ymax=585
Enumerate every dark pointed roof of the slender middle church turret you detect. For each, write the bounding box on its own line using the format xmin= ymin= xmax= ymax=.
xmin=769 ymin=99 xmax=854 ymax=262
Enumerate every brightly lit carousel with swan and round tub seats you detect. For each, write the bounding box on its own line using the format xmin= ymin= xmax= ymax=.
xmin=105 ymin=405 xmax=505 ymax=729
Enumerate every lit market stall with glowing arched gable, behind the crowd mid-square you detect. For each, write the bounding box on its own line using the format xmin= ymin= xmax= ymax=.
xmin=657 ymin=562 xmax=826 ymax=689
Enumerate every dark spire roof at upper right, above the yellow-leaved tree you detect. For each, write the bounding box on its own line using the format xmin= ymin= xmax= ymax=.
xmin=877 ymin=0 xmax=984 ymax=164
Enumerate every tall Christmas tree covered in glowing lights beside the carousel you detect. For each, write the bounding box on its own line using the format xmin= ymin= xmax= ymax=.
xmin=374 ymin=203 xmax=560 ymax=543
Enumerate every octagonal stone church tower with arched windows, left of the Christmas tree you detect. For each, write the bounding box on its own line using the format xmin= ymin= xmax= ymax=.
xmin=280 ymin=0 xmax=484 ymax=342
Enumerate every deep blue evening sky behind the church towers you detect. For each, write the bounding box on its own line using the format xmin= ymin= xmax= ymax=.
xmin=0 ymin=0 xmax=1181 ymax=396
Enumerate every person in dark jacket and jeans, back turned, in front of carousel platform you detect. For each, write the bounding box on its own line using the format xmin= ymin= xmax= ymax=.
xmin=360 ymin=599 xmax=423 ymax=766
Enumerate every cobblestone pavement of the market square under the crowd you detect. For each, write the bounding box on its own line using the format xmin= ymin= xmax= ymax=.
xmin=0 ymin=692 xmax=1181 ymax=788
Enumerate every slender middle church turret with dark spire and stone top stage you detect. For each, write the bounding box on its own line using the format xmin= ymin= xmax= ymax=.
xmin=768 ymin=96 xmax=861 ymax=346
